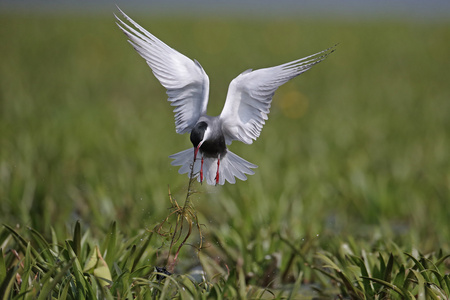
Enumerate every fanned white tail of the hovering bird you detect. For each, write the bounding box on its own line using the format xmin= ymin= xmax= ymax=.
xmin=169 ymin=148 xmax=258 ymax=185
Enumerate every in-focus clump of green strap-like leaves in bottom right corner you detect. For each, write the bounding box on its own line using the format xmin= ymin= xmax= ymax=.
xmin=313 ymin=240 xmax=450 ymax=300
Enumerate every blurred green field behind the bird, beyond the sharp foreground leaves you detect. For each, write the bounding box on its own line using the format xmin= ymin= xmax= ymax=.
xmin=0 ymin=4 xmax=450 ymax=262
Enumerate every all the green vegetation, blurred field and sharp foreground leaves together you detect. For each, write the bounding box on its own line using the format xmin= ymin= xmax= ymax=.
xmin=0 ymin=11 xmax=450 ymax=299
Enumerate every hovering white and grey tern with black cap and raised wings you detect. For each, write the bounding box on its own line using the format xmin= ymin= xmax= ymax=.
xmin=114 ymin=7 xmax=336 ymax=185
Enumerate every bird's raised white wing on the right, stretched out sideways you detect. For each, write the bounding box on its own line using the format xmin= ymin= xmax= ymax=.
xmin=220 ymin=46 xmax=335 ymax=144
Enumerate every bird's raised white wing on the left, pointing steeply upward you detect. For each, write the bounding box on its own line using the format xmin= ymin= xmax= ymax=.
xmin=116 ymin=9 xmax=209 ymax=134
